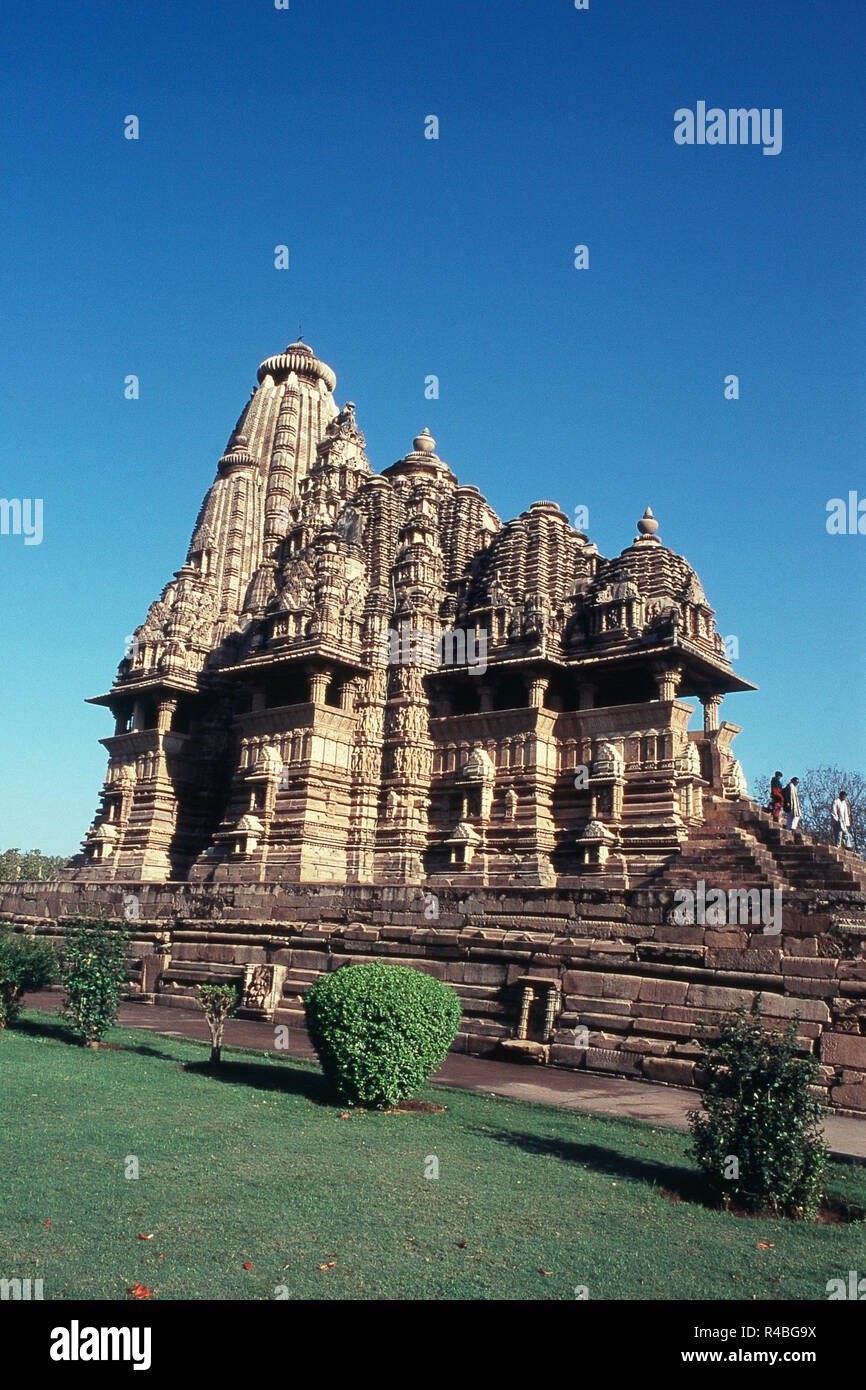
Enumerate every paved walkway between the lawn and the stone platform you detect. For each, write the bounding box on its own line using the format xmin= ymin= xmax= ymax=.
xmin=24 ymin=994 xmax=866 ymax=1162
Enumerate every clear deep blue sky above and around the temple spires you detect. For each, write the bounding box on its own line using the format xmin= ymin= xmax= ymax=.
xmin=0 ymin=0 xmax=866 ymax=853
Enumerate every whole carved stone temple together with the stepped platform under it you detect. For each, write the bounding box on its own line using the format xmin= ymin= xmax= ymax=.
xmin=0 ymin=342 xmax=866 ymax=1112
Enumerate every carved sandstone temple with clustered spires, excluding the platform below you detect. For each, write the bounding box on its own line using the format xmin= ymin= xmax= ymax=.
xmin=72 ymin=342 xmax=755 ymax=888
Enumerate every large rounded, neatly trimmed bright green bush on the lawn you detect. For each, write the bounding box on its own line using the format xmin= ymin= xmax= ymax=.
xmin=304 ymin=960 xmax=460 ymax=1106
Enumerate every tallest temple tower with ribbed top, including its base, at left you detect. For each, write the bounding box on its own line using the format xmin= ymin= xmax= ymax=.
xmin=75 ymin=342 xmax=338 ymax=881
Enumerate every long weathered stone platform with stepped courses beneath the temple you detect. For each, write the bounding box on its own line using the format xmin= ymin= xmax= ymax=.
xmin=0 ymin=831 xmax=866 ymax=1115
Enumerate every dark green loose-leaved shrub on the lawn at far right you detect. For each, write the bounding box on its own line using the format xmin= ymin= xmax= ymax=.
xmin=688 ymin=1009 xmax=827 ymax=1220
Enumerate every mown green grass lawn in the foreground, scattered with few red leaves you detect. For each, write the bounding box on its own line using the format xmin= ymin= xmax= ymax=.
xmin=0 ymin=1011 xmax=866 ymax=1300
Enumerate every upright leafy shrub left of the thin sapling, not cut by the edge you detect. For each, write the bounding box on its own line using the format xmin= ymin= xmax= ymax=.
xmin=63 ymin=916 xmax=129 ymax=1047
